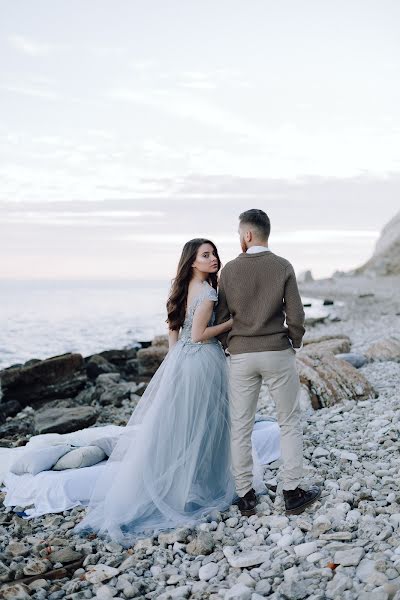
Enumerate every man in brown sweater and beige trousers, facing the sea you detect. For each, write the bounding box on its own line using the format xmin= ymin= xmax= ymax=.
xmin=216 ymin=209 xmax=321 ymax=515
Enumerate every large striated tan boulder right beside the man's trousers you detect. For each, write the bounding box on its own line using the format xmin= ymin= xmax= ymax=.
xmin=297 ymin=349 xmax=377 ymax=409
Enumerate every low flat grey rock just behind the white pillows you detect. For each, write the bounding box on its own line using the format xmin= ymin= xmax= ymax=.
xmin=35 ymin=406 xmax=98 ymax=433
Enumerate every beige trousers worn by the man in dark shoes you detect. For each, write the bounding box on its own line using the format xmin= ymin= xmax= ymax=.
xmin=228 ymin=348 xmax=303 ymax=497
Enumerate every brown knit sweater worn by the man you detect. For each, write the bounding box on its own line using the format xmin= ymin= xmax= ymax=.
xmin=216 ymin=251 xmax=305 ymax=354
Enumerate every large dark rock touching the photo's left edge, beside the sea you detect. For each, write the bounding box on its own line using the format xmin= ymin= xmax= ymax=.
xmin=0 ymin=353 xmax=87 ymax=406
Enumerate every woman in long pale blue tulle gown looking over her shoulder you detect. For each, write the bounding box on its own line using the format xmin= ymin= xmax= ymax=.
xmin=75 ymin=239 xmax=258 ymax=547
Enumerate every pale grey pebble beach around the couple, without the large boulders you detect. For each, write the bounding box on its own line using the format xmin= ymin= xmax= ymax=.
xmin=0 ymin=276 xmax=400 ymax=600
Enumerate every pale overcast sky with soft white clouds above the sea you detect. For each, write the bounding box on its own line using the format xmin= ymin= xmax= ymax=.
xmin=0 ymin=0 xmax=400 ymax=279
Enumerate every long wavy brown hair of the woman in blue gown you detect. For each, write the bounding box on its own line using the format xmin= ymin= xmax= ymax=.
xmin=167 ymin=238 xmax=221 ymax=330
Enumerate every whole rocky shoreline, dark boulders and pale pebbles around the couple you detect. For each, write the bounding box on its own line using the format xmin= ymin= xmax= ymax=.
xmin=0 ymin=276 xmax=400 ymax=600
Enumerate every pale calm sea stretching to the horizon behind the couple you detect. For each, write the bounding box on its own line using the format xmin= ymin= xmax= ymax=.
xmin=0 ymin=280 xmax=323 ymax=369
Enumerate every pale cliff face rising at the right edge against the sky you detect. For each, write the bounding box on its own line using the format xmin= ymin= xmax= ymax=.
xmin=356 ymin=212 xmax=400 ymax=275
